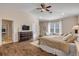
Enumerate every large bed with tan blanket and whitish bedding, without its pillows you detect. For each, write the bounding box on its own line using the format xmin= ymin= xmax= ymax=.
xmin=39 ymin=36 xmax=76 ymax=56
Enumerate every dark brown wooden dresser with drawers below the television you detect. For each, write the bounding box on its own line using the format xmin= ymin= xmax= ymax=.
xmin=18 ymin=31 xmax=33 ymax=42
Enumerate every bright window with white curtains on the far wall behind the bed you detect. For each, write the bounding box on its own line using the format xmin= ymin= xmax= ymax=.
xmin=48 ymin=21 xmax=62 ymax=35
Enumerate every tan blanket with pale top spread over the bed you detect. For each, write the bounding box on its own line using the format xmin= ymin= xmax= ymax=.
xmin=39 ymin=36 xmax=69 ymax=53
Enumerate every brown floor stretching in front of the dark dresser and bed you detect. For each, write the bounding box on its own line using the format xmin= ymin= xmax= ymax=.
xmin=0 ymin=41 xmax=53 ymax=56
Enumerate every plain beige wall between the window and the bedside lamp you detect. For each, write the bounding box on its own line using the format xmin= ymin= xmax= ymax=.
xmin=61 ymin=16 xmax=78 ymax=33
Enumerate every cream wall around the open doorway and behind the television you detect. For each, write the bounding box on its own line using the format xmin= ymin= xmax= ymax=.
xmin=0 ymin=9 xmax=39 ymax=42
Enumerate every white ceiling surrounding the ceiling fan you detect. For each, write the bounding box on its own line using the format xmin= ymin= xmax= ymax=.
xmin=0 ymin=3 xmax=79 ymax=20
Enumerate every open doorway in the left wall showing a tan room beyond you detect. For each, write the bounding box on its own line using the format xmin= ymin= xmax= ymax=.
xmin=2 ymin=19 xmax=13 ymax=44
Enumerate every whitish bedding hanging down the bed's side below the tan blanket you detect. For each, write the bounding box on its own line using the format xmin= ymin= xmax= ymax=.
xmin=39 ymin=43 xmax=76 ymax=56
